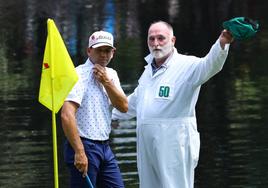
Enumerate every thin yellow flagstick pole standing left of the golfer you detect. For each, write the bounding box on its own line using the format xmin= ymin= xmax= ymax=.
xmin=47 ymin=18 xmax=59 ymax=188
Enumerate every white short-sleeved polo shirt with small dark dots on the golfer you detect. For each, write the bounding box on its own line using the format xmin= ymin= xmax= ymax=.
xmin=65 ymin=59 xmax=123 ymax=140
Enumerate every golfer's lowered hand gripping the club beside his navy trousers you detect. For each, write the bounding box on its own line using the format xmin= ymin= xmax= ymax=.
xmin=74 ymin=151 xmax=88 ymax=177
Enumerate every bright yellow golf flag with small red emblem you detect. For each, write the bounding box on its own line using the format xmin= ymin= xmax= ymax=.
xmin=39 ymin=19 xmax=78 ymax=113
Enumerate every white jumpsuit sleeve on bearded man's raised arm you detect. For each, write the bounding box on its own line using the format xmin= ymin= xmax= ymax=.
xmin=191 ymin=39 xmax=230 ymax=86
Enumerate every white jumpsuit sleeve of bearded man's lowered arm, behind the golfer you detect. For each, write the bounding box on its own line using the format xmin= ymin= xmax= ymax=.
xmin=112 ymin=88 xmax=137 ymax=120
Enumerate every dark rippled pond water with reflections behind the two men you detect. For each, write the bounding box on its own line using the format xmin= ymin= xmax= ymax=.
xmin=0 ymin=0 xmax=268 ymax=188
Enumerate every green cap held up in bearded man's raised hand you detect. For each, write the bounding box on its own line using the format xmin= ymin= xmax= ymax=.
xmin=222 ymin=17 xmax=259 ymax=40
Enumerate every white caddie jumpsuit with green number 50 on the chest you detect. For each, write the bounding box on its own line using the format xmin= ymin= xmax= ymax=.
xmin=112 ymin=40 xmax=229 ymax=188
